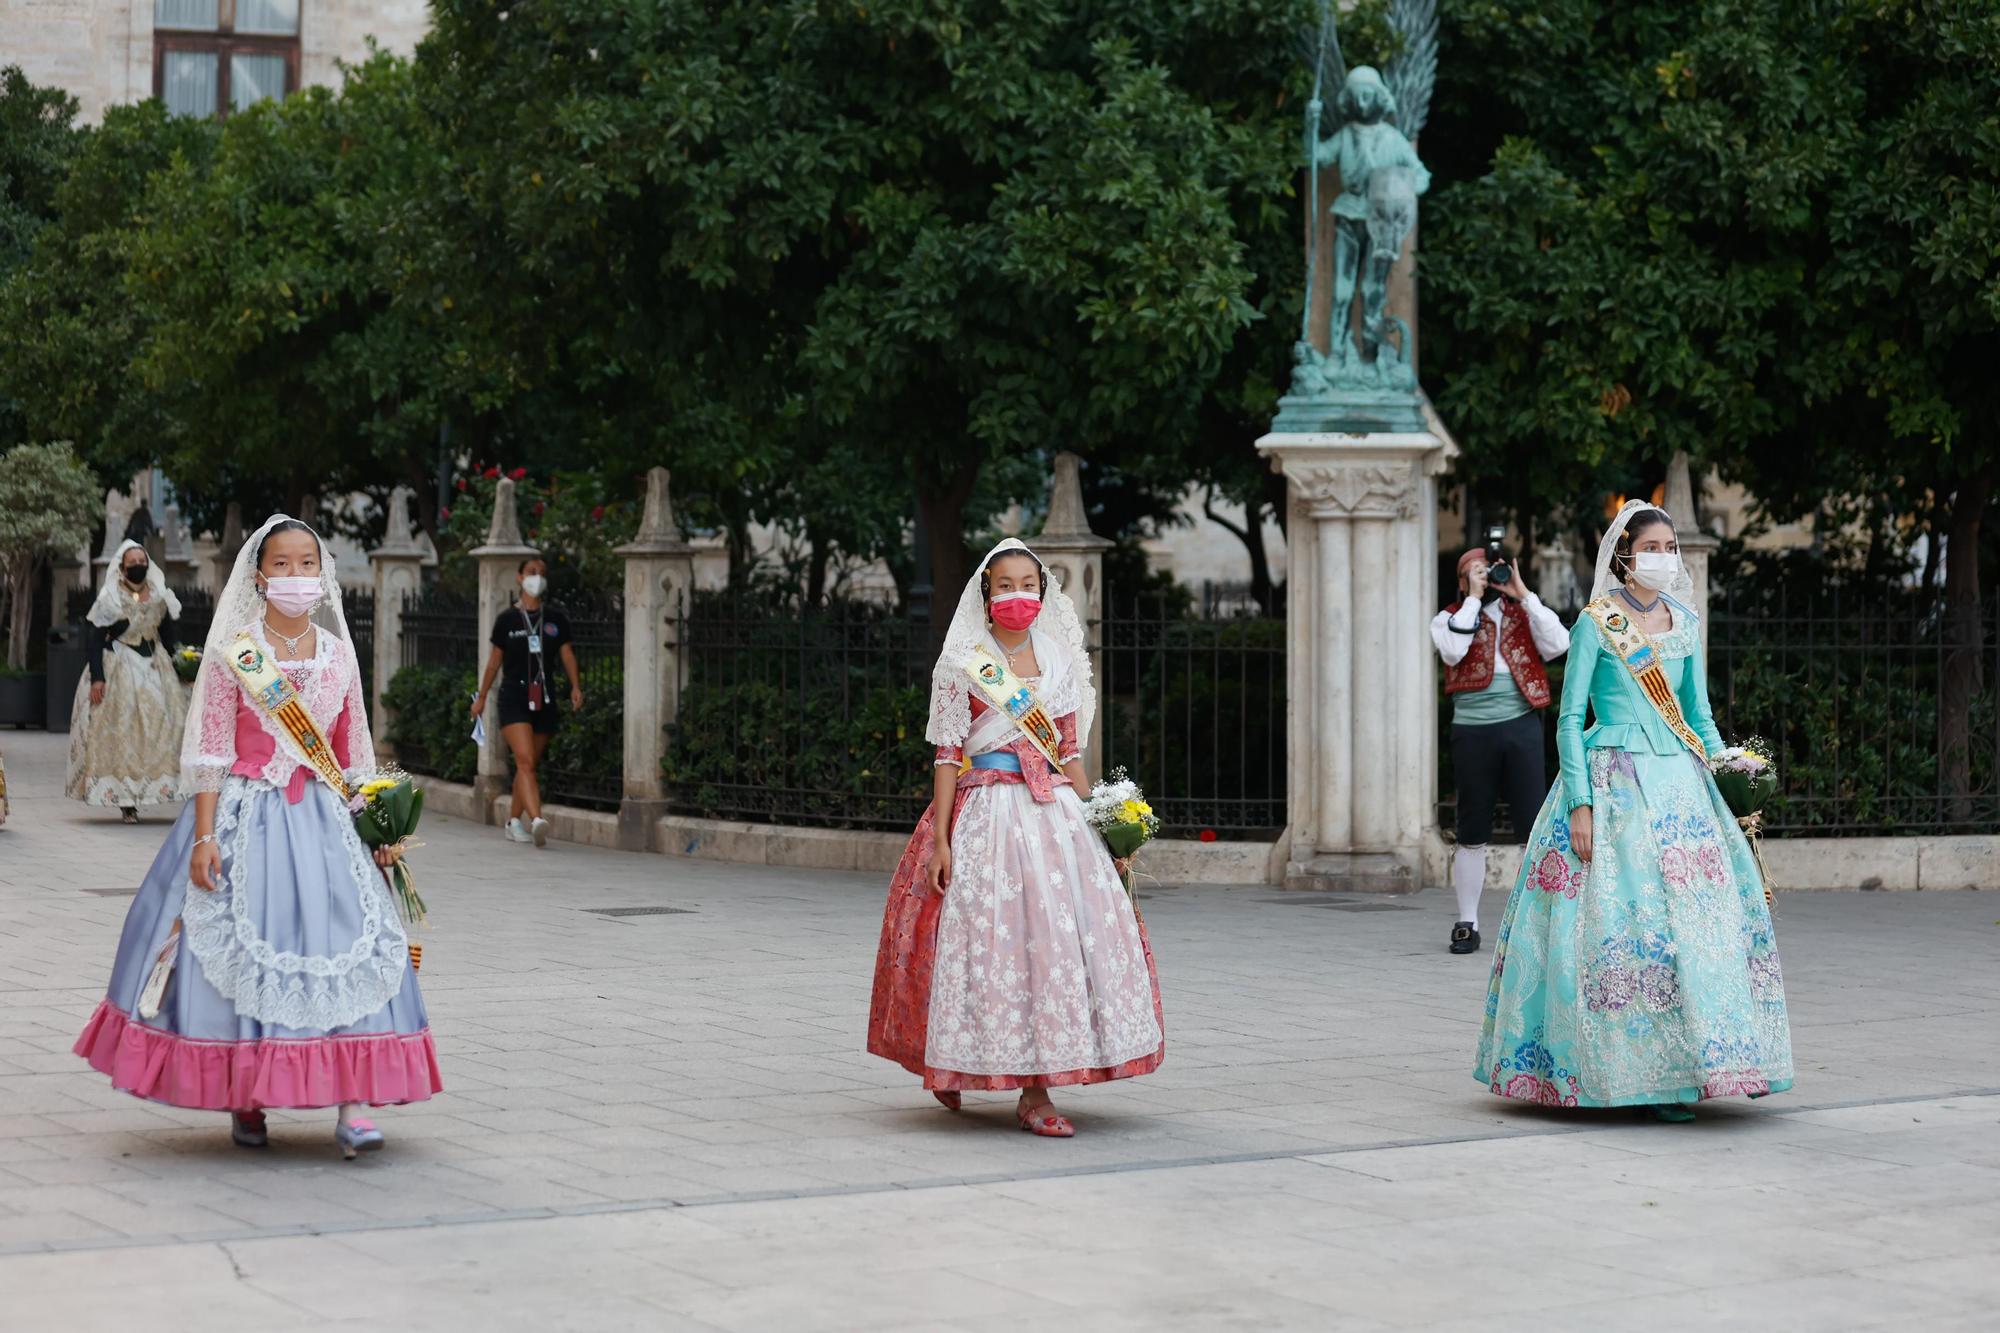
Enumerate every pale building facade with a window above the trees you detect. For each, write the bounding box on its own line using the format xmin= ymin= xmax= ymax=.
xmin=0 ymin=0 xmax=430 ymax=124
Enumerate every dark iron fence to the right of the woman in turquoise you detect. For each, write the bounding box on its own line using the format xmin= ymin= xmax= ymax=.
xmin=1708 ymin=584 xmax=2000 ymax=837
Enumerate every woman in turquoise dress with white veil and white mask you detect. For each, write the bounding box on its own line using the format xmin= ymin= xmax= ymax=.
xmin=1472 ymin=500 xmax=1792 ymax=1121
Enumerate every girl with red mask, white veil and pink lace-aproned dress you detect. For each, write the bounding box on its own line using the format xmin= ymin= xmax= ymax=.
xmin=868 ymin=538 xmax=1166 ymax=1137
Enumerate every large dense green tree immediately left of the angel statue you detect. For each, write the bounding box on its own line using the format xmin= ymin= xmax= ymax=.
xmin=418 ymin=0 xmax=1310 ymax=600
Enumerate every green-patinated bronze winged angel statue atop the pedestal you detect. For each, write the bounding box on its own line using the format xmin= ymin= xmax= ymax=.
xmin=1292 ymin=0 xmax=1438 ymax=396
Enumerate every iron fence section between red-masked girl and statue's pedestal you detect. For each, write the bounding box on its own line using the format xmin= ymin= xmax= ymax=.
xmin=1098 ymin=596 xmax=1286 ymax=839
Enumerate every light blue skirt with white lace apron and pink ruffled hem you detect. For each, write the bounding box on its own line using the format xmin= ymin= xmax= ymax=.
xmin=76 ymin=777 xmax=442 ymax=1111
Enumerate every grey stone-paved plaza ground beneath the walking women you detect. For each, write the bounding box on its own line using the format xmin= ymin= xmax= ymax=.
xmin=0 ymin=733 xmax=2000 ymax=1333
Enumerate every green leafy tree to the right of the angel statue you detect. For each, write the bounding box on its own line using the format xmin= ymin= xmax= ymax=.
xmin=1424 ymin=0 xmax=2000 ymax=808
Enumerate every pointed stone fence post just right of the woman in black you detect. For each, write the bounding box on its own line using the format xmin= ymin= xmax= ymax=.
xmin=618 ymin=468 xmax=694 ymax=851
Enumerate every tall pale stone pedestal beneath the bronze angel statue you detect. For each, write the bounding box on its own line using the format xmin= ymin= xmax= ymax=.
xmin=1258 ymin=398 xmax=1458 ymax=891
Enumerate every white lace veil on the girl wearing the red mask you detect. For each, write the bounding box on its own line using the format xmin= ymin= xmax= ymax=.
xmin=924 ymin=536 xmax=1098 ymax=747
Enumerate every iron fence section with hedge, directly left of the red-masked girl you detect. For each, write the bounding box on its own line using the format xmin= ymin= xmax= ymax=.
xmin=666 ymin=594 xmax=932 ymax=831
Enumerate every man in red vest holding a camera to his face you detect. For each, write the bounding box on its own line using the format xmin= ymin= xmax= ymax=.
xmin=1430 ymin=528 xmax=1570 ymax=953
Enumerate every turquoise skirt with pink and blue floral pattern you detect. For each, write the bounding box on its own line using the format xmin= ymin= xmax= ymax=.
xmin=1472 ymin=749 xmax=1792 ymax=1107
